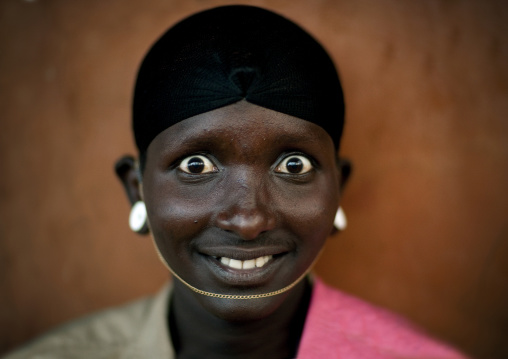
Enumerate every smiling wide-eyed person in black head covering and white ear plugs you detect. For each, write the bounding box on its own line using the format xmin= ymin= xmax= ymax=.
xmin=3 ymin=5 xmax=470 ymax=359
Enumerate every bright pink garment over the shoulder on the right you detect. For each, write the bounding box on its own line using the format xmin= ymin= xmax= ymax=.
xmin=298 ymin=280 xmax=466 ymax=359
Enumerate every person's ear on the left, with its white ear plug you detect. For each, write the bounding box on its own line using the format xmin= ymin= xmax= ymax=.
xmin=115 ymin=155 xmax=148 ymax=234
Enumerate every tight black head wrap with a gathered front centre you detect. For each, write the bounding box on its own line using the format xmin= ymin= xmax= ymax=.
xmin=133 ymin=5 xmax=344 ymax=155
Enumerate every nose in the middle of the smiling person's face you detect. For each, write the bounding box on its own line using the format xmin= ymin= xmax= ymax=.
xmin=217 ymin=173 xmax=276 ymax=240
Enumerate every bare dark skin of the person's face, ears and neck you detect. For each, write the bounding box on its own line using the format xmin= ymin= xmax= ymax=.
xmin=117 ymin=101 xmax=350 ymax=358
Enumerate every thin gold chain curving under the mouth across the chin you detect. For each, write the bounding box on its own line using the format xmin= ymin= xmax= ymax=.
xmin=150 ymin=232 xmax=324 ymax=300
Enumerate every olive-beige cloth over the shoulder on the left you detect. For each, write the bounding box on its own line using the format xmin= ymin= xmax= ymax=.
xmin=4 ymin=284 xmax=175 ymax=359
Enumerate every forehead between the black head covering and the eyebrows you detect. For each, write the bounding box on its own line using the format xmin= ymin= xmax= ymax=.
xmin=148 ymin=101 xmax=334 ymax=158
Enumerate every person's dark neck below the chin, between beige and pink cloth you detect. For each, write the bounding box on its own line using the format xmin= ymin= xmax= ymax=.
xmin=169 ymin=280 xmax=311 ymax=359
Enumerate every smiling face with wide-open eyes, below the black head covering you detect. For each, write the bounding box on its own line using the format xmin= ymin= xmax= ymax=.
xmin=143 ymin=101 xmax=340 ymax=318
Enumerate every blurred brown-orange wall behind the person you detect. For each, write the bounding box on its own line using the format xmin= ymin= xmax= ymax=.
xmin=0 ymin=0 xmax=508 ymax=358
